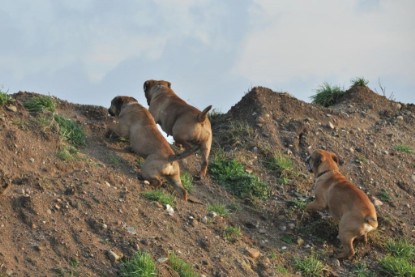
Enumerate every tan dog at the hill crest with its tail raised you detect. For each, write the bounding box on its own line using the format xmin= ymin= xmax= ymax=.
xmin=144 ymin=80 xmax=212 ymax=177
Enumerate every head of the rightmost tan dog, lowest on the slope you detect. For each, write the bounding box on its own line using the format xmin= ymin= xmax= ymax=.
xmin=306 ymin=149 xmax=341 ymax=174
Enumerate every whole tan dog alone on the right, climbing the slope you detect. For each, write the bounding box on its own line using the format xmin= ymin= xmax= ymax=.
xmin=306 ymin=150 xmax=378 ymax=259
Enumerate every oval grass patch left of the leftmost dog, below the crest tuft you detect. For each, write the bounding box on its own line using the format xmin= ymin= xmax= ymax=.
xmin=55 ymin=115 xmax=86 ymax=146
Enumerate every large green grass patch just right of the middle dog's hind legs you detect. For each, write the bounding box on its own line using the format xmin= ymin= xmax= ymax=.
xmin=209 ymin=156 xmax=270 ymax=200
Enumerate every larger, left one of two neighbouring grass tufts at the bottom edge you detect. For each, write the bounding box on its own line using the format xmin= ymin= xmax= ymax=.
xmin=120 ymin=252 xmax=157 ymax=277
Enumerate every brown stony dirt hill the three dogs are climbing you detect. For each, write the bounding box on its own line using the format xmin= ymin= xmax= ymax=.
xmin=0 ymin=87 xmax=415 ymax=276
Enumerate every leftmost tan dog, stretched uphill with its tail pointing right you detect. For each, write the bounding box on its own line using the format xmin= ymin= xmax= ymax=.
xmin=108 ymin=96 xmax=192 ymax=201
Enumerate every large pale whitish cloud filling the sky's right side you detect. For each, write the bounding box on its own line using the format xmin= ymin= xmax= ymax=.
xmin=233 ymin=0 xmax=415 ymax=88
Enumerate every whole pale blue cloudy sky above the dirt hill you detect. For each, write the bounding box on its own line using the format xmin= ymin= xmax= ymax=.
xmin=0 ymin=0 xmax=415 ymax=112
